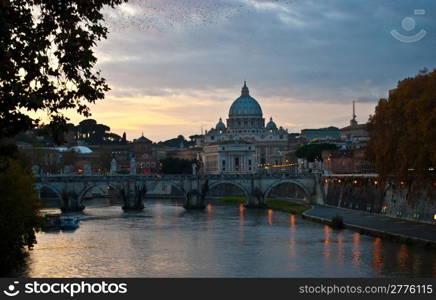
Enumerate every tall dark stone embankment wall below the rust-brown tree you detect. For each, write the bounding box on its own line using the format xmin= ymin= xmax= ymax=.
xmin=323 ymin=175 xmax=436 ymax=225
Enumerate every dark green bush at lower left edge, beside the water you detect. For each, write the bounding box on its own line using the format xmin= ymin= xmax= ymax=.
xmin=0 ymin=159 xmax=43 ymax=276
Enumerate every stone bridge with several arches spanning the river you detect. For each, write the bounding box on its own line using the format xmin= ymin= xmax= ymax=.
xmin=35 ymin=174 xmax=323 ymax=211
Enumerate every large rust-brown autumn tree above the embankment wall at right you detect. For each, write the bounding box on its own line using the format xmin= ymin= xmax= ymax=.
xmin=367 ymin=70 xmax=436 ymax=182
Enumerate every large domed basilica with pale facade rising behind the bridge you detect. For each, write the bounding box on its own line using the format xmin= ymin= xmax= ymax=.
xmin=197 ymin=82 xmax=289 ymax=174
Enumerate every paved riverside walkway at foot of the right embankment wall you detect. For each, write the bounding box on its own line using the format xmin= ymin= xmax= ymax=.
xmin=303 ymin=205 xmax=436 ymax=248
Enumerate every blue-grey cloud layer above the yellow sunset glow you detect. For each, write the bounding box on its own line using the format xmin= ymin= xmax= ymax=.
xmin=99 ymin=0 xmax=436 ymax=101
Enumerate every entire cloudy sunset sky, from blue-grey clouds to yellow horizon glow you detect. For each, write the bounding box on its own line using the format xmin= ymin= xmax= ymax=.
xmin=48 ymin=0 xmax=436 ymax=142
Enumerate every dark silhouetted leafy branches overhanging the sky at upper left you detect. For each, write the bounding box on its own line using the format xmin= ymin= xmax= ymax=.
xmin=0 ymin=0 xmax=126 ymax=142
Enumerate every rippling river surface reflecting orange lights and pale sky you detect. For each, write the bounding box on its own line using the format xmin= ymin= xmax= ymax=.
xmin=22 ymin=200 xmax=436 ymax=277
